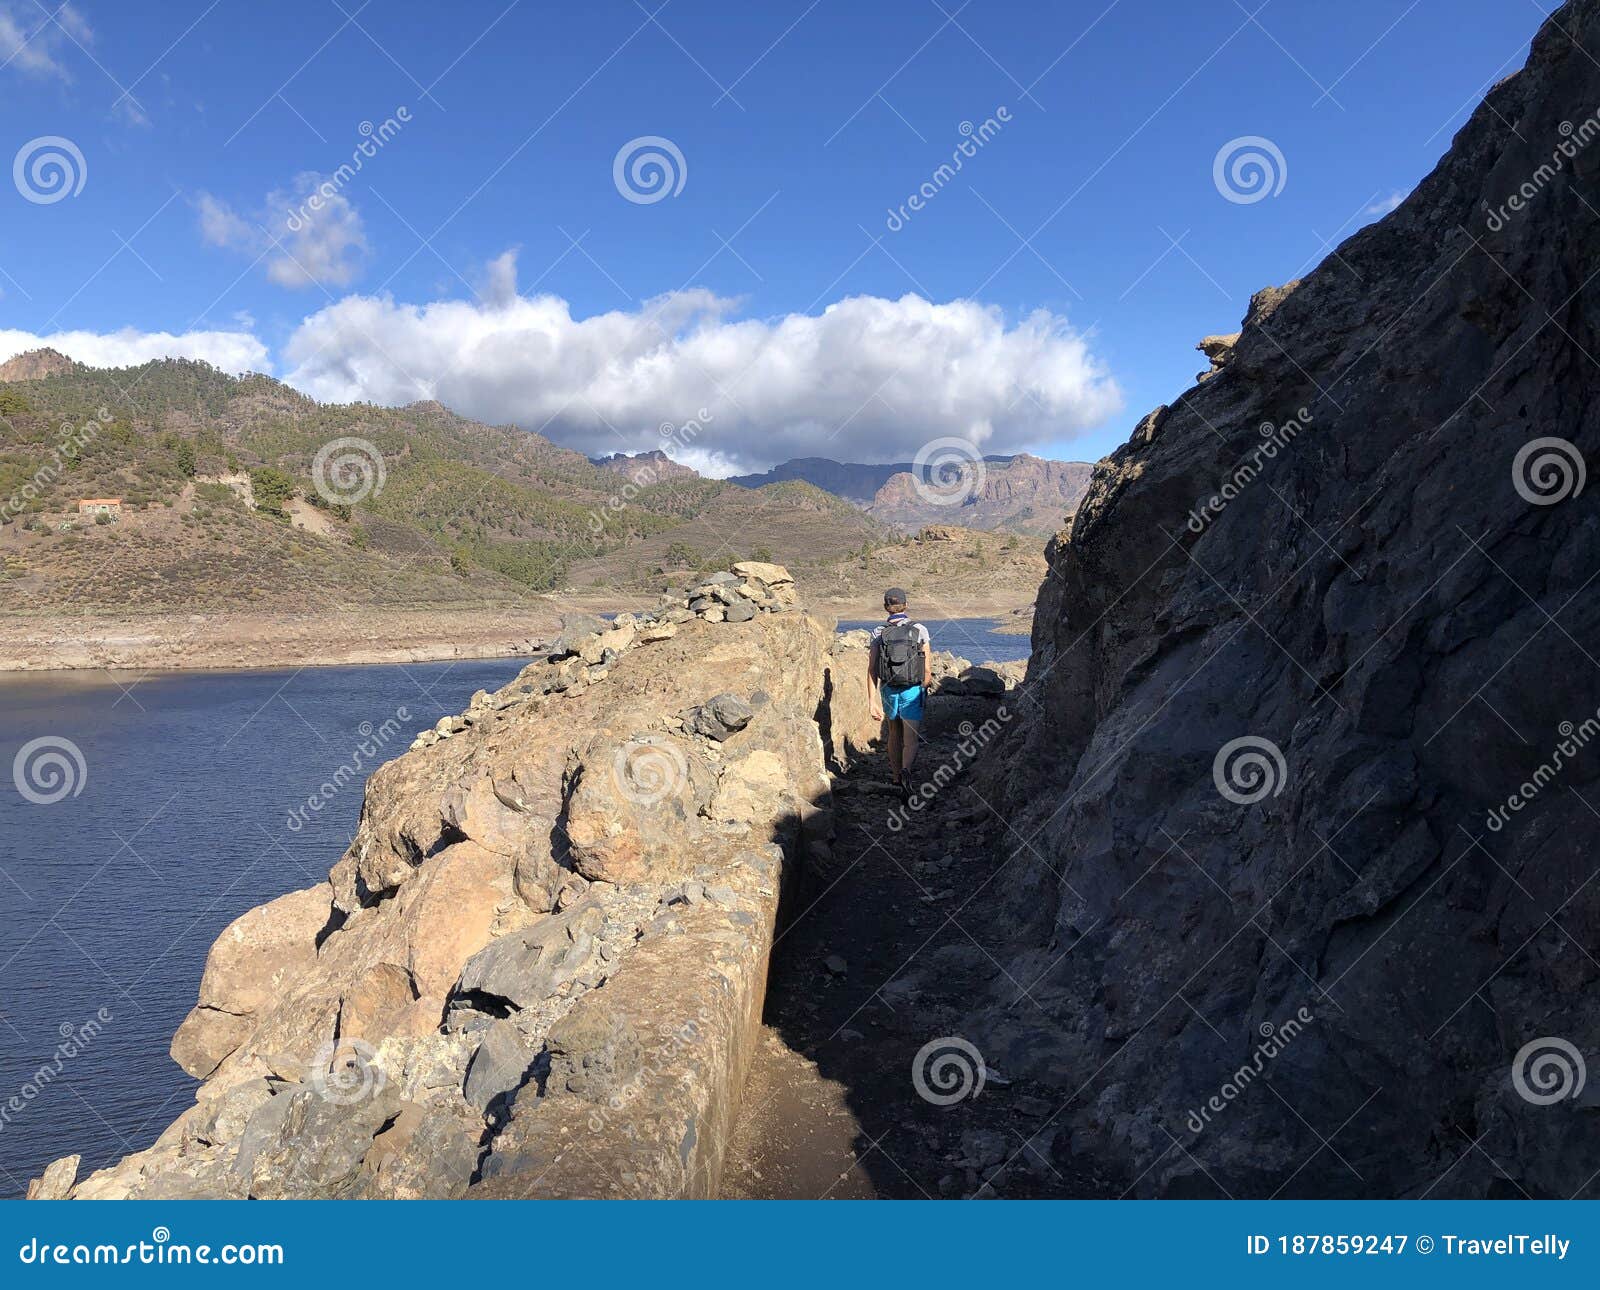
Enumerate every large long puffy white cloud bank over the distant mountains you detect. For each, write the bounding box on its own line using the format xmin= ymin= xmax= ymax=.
xmin=283 ymin=256 xmax=1122 ymax=474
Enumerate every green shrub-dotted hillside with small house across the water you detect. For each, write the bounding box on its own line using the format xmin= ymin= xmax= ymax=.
xmin=0 ymin=360 xmax=888 ymax=610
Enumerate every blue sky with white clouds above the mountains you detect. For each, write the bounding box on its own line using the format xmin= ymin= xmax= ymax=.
xmin=0 ymin=0 xmax=1554 ymax=471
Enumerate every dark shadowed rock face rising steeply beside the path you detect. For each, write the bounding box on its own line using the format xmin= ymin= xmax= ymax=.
xmin=968 ymin=0 xmax=1600 ymax=1197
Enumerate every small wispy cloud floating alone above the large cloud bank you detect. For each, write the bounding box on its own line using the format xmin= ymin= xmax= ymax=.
xmin=195 ymin=170 xmax=366 ymax=288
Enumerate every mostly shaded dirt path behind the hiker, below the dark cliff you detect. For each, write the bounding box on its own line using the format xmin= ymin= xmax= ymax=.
xmin=723 ymin=699 xmax=1104 ymax=1199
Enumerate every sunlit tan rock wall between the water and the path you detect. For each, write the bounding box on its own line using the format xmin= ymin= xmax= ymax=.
xmin=51 ymin=563 xmax=843 ymax=1199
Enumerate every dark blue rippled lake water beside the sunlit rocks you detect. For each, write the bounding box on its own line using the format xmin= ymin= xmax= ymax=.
xmin=0 ymin=619 xmax=1027 ymax=1196
